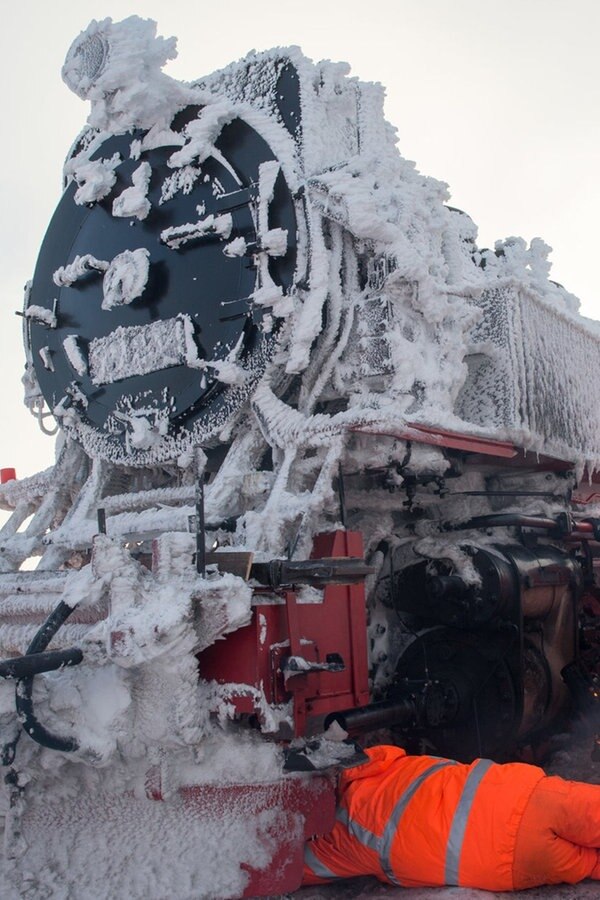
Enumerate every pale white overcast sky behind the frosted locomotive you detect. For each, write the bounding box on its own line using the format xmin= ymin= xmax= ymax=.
xmin=0 ymin=0 xmax=600 ymax=476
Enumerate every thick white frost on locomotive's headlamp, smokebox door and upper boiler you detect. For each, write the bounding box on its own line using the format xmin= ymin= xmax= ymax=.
xmin=37 ymin=17 xmax=600 ymax=465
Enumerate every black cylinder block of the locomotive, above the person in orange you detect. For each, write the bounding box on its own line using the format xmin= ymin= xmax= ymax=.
xmin=379 ymin=540 xmax=583 ymax=760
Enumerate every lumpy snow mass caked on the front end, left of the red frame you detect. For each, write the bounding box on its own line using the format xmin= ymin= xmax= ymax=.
xmin=0 ymin=534 xmax=255 ymax=768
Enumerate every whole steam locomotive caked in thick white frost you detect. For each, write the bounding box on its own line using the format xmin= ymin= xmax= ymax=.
xmin=0 ymin=17 xmax=600 ymax=898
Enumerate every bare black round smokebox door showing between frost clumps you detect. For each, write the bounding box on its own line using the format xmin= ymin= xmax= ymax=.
xmin=28 ymin=101 xmax=299 ymax=458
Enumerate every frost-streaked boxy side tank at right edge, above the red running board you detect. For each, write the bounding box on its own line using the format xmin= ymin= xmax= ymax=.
xmin=456 ymin=287 xmax=600 ymax=460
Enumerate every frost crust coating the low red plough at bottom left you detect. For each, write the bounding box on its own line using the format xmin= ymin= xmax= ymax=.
xmin=0 ymin=790 xmax=302 ymax=900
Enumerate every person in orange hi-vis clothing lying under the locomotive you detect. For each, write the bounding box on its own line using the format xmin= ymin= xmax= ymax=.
xmin=303 ymin=746 xmax=600 ymax=891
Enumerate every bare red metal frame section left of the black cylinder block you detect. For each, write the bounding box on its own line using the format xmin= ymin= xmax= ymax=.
xmin=198 ymin=531 xmax=369 ymax=737
